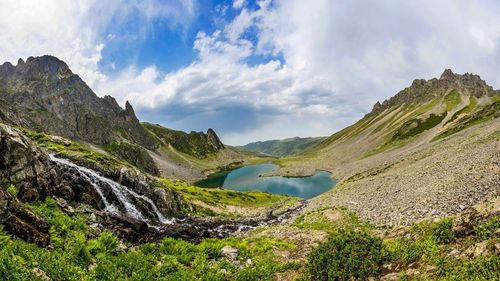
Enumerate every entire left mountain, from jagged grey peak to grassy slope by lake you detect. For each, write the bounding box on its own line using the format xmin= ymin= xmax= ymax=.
xmin=0 ymin=56 xmax=254 ymax=181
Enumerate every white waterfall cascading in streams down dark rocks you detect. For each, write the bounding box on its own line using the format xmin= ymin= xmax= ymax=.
xmin=49 ymin=154 xmax=173 ymax=224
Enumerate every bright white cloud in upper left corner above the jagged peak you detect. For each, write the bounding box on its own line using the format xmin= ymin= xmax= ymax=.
xmin=0 ymin=0 xmax=197 ymax=87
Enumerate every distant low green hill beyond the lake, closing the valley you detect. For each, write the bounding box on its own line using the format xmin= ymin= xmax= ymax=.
xmin=238 ymin=137 xmax=326 ymax=156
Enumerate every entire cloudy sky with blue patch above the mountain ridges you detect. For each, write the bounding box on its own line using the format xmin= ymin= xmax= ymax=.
xmin=0 ymin=0 xmax=500 ymax=144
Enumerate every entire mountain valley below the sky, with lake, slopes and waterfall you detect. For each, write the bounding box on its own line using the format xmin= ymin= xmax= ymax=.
xmin=0 ymin=56 xmax=500 ymax=280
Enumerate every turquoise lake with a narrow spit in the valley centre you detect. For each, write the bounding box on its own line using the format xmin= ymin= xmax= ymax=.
xmin=195 ymin=164 xmax=337 ymax=199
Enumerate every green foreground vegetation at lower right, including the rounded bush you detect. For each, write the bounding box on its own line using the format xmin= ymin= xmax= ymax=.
xmin=294 ymin=205 xmax=500 ymax=280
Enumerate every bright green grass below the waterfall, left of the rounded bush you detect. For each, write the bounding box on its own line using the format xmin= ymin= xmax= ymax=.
xmin=0 ymin=198 xmax=300 ymax=281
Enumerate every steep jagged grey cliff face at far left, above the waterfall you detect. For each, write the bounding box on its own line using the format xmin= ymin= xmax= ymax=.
xmin=0 ymin=56 xmax=158 ymax=149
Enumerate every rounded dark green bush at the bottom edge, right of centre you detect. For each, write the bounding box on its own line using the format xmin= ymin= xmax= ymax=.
xmin=306 ymin=230 xmax=383 ymax=281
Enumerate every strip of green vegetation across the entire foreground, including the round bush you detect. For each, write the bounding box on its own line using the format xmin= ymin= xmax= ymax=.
xmin=0 ymin=188 xmax=500 ymax=280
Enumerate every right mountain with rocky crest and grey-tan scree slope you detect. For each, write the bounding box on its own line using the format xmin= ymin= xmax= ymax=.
xmin=278 ymin=70 xmax=500 ymax=225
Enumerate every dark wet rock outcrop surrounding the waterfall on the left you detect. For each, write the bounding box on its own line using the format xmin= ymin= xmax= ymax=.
xmin=0 ymin=123 xmax=182 ymax=243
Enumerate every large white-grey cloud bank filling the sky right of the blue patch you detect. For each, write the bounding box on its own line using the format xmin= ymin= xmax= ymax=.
xmin=104 ymin=0 xmax=500 ymax=143
